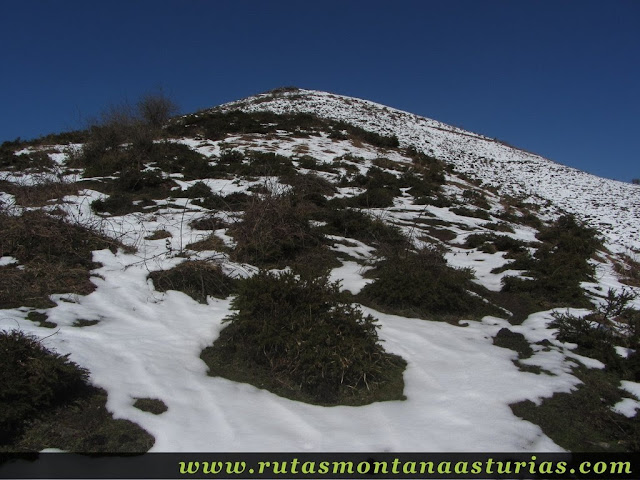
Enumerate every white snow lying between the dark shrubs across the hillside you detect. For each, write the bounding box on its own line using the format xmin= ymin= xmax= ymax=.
xmin=0 ymin=90 xmax=640 ymax=451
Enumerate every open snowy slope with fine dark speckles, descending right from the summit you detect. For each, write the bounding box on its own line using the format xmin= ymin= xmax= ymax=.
xmin=219 ymin=90 xmax=640 ymax=252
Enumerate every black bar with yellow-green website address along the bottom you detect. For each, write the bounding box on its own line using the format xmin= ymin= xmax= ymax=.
xmin=0 ymin=452 xmax=640 ymax=480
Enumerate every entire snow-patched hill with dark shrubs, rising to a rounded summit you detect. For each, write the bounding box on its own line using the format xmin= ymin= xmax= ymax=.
xmin=0 ymin=88 xmax=640 ymax=452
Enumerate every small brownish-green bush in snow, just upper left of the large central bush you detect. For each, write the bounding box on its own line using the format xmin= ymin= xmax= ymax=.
xmin=149 ymin=260 xmax=236 ymax=303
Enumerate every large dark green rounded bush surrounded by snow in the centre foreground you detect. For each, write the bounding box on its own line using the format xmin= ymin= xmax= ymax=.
xmin=202 ymin=271 xmax=406 ymax=405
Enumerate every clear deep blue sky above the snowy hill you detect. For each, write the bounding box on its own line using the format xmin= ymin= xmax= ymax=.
xmin=0 ymin=0 xmax=640 ymax=181
